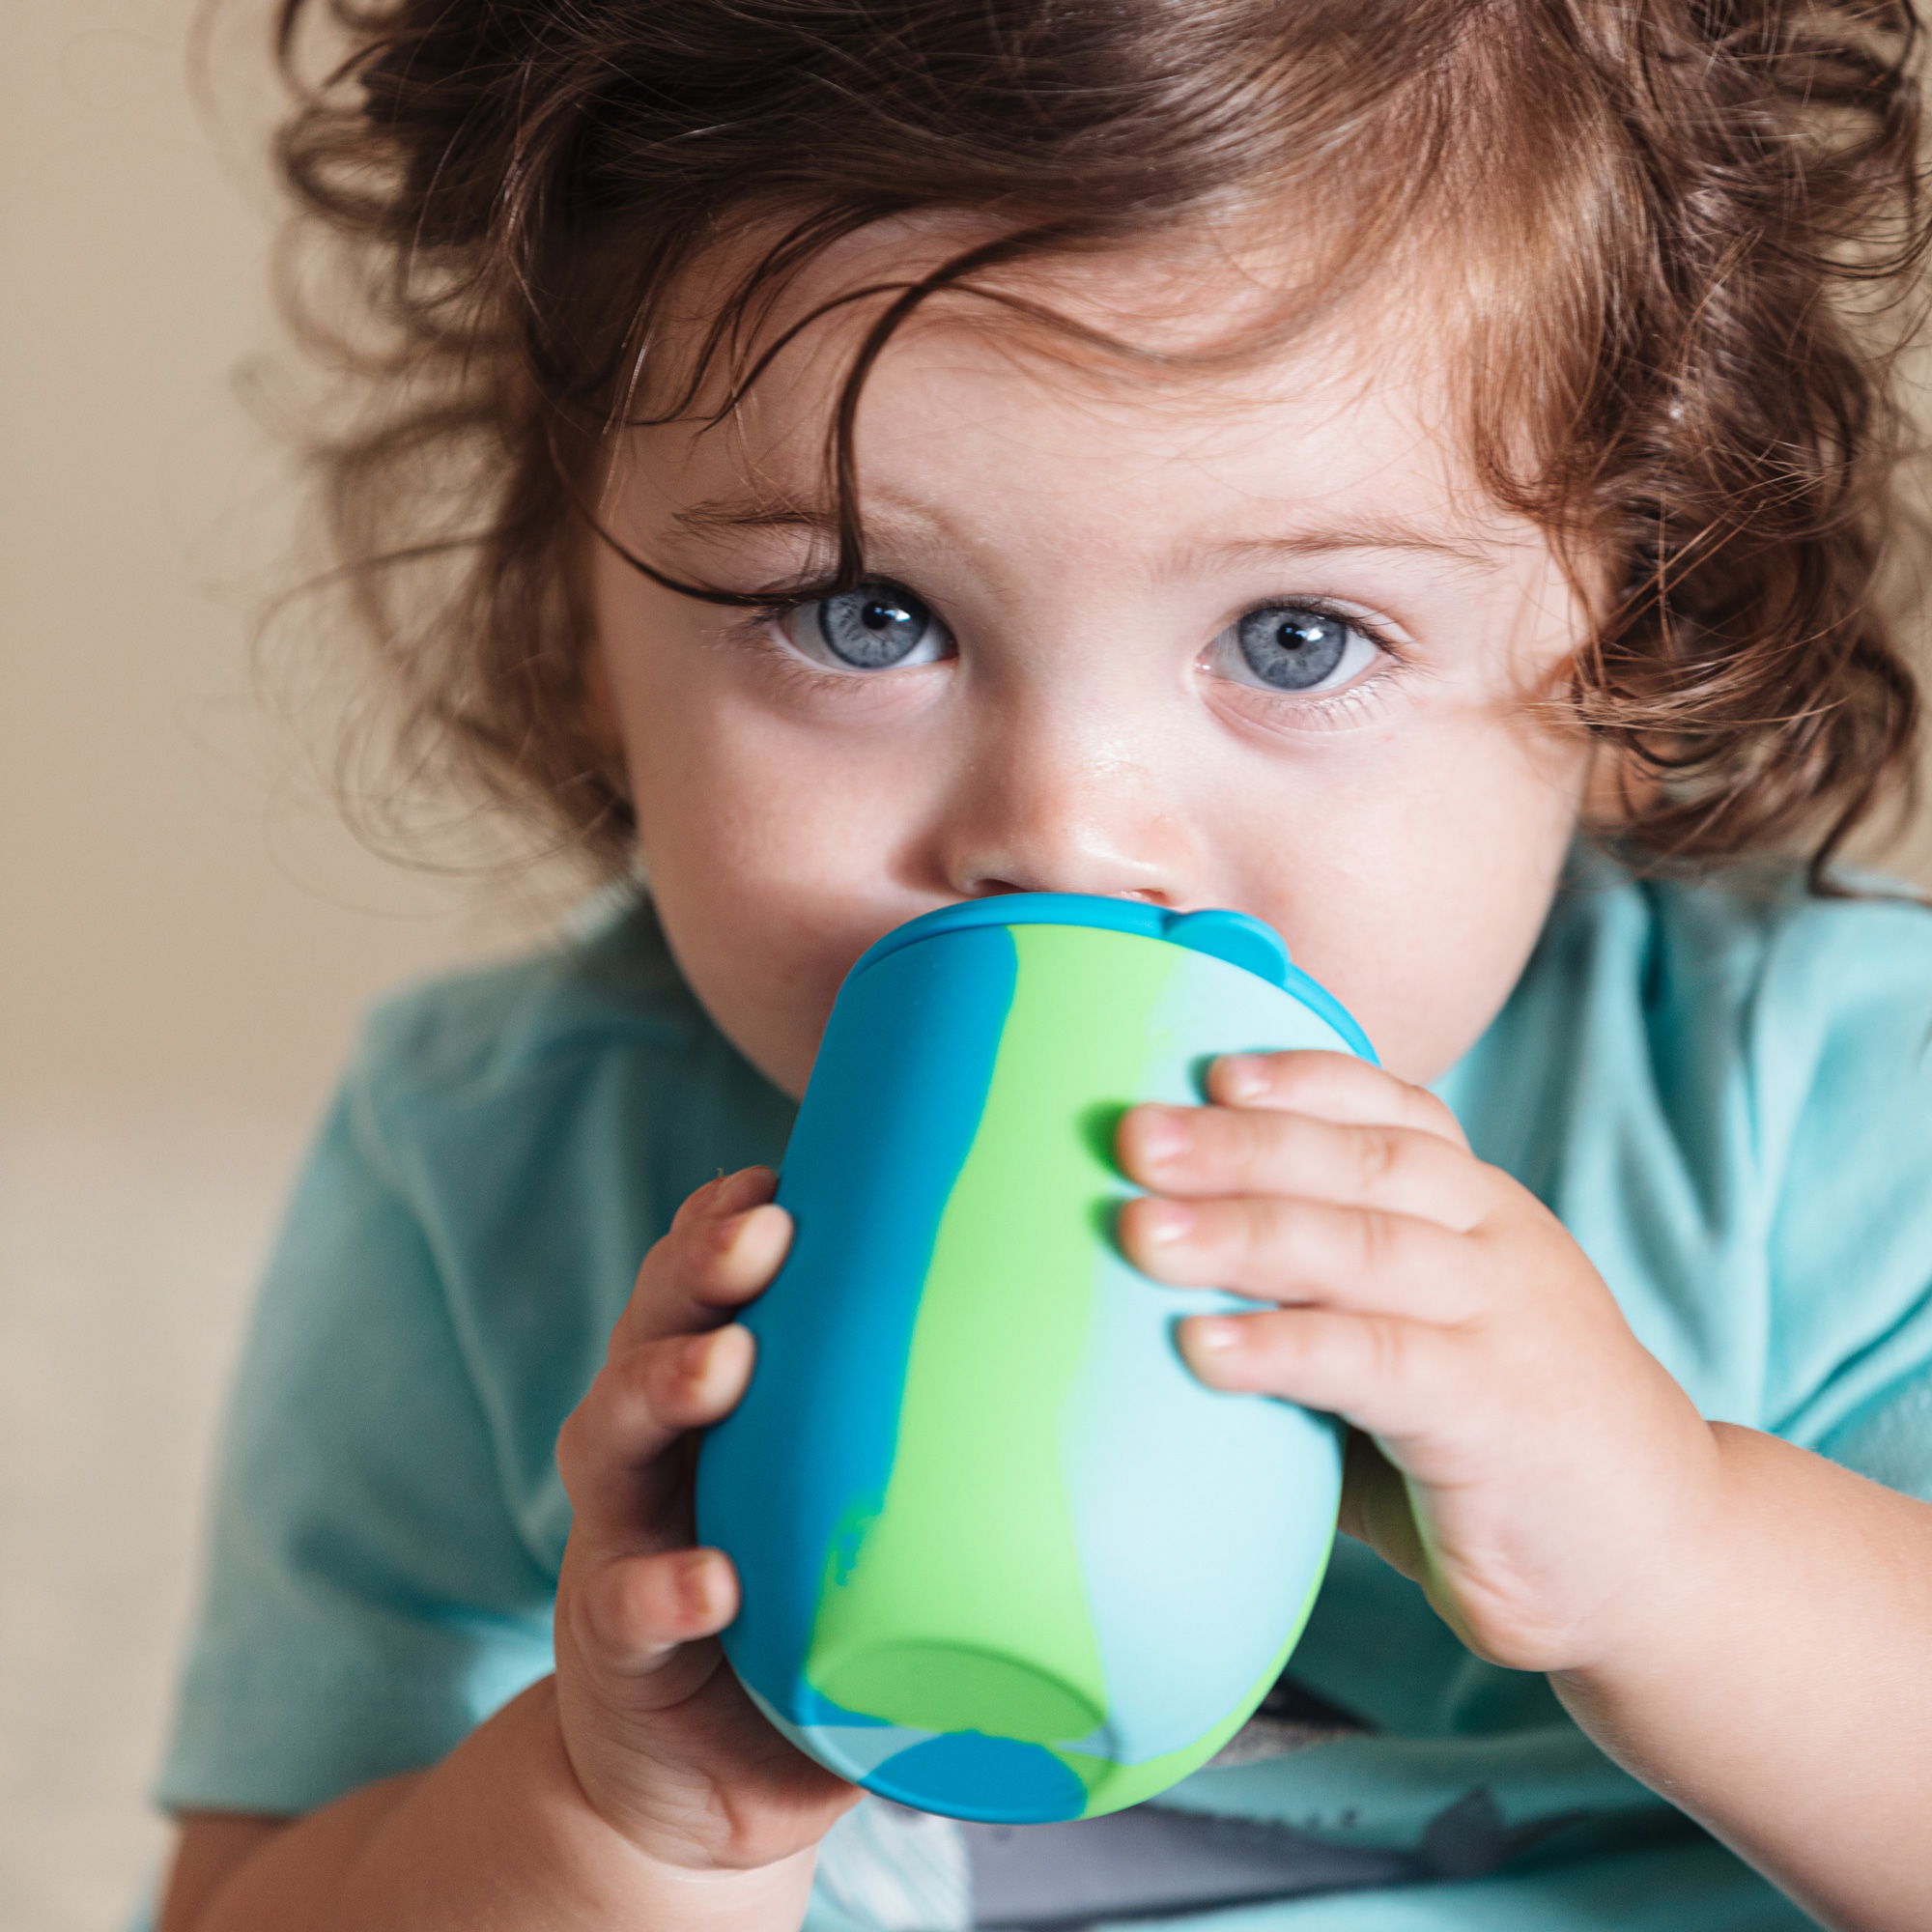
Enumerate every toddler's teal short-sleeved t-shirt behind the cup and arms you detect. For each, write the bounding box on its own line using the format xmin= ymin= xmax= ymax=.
xmin=158 ymin=860 xmax=1932 ymax=1932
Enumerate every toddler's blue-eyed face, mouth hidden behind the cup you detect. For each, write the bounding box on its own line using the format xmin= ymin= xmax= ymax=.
xmin=595 ymin=232 xmax=1588 ymax=1095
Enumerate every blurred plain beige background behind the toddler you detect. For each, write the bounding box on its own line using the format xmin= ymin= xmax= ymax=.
xmin=0 ymin=0 xmax=1924 ymax=1932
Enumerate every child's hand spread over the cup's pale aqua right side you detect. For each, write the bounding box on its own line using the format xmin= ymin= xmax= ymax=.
xmin=1119 ymin=1053 xmax=1721 ymax=1671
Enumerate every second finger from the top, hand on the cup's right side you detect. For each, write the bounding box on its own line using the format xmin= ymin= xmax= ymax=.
xmin=1117 ymin=1105 xmax=1495 ymax=1233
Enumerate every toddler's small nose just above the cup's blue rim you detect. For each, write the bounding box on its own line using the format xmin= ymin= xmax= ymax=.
xmin=937 ymin=724 xmax=1196 ymax=906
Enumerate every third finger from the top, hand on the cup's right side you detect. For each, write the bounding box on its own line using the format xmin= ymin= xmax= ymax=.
xmin=1119 ymin=1194 xmax=1488 ymax=1323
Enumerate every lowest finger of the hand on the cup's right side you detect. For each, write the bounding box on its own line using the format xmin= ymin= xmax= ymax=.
xmin=1179 ymin=1308 xmax=1461 ymax=1445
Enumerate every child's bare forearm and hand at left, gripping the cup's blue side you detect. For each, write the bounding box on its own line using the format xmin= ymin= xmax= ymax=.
xmin=162 ymin=1167 xmax=860 ymax=1932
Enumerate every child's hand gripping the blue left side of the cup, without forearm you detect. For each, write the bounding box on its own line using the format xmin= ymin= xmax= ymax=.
xmin=556 ymin=1167 xmax=860 ymax=1870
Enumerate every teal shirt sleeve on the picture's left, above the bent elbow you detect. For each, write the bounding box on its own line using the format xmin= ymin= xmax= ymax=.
xmin=156 ymin=1074 xmax=554 ymax=1812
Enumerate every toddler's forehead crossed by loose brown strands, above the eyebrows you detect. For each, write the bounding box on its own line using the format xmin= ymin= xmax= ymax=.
xmin=653 ymin=216 xmax=1530 ymax=560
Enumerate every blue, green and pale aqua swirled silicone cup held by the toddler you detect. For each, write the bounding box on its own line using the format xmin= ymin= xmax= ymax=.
xmin=697 ymin=895 xmax=1372 ymax=1824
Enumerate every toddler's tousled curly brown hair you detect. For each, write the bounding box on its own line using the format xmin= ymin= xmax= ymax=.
xmin=278 ymin=0 xmax=1926 ymax=881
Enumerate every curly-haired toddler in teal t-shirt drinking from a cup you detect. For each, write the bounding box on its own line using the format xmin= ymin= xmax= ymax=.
xmin=160 ymin=0 xmax=1932 ymax=1932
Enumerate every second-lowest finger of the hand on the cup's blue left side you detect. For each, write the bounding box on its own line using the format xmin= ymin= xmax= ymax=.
xmin=556 ymin=1323 xmax=755 ymax=1549
